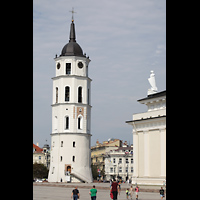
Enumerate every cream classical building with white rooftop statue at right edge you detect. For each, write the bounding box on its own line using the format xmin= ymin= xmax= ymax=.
xmin=126 ymin=71 xmax=166 ymax=185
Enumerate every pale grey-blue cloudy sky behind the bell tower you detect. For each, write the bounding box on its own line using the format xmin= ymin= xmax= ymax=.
xmin=33 ymin=0 xmax=166 ymax=147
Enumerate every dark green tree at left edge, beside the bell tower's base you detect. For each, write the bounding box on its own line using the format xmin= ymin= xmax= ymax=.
xmin=33 ymin=163 xmax=49 ymax=178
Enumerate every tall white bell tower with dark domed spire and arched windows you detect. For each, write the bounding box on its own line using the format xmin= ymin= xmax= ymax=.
xmin=48 ymin=18 xmax=93 ymax=182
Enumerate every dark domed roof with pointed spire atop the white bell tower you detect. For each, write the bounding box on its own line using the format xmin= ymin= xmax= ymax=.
xmin=60 ymin=20 xmax=86 ymax=57
